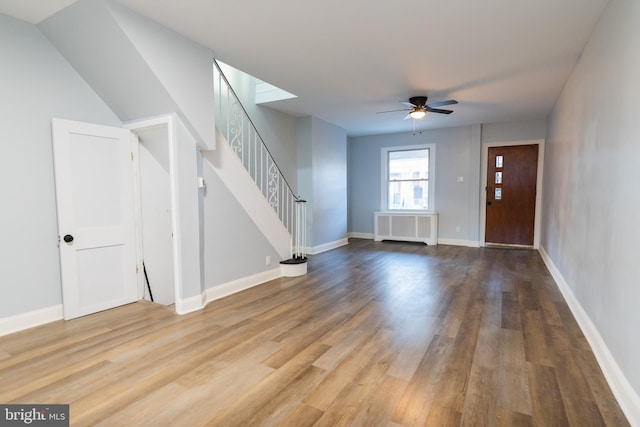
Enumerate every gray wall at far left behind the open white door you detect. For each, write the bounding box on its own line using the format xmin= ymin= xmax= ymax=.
xmin=0 ymin=14 xmax=120 ymax=318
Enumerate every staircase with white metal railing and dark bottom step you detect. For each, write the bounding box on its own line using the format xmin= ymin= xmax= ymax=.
xmin=212 ymin=60 xmax=307 ymax=276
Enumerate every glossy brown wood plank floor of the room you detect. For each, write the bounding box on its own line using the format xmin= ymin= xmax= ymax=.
xmin=0 ymin=239 xmax=628 ymax=427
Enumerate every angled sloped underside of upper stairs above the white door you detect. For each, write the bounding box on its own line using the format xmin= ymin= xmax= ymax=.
xmin=38 ymin=0 xmax=215 ymax=149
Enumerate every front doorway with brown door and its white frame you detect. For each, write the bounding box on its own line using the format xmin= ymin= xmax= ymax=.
xmin=481 ymin=140 xmax=544 ymax=248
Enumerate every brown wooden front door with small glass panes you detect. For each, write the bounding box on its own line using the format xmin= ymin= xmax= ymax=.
xmin=485 ymin=144 xmax=538 ymax=245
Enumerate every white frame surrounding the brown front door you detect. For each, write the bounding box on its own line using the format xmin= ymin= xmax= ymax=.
xmin=480 ymin=139 xmax=544 ymax=249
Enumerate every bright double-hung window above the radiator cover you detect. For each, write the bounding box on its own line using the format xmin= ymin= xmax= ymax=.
xmin=381 ymin=144 xmax=435 ymax=211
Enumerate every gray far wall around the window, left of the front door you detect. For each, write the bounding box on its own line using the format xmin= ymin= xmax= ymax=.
xmin=349 ymin=126 xmax=480 ymax=241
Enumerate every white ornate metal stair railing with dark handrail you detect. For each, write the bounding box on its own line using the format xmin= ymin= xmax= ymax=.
xmin=213 ymin=59 xmax=306 ymax=259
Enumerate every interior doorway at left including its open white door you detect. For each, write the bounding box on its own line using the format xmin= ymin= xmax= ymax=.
xmin=52 ymin=116 xmax=181 ymax=319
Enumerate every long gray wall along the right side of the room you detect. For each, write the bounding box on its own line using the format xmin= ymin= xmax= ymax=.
xmin=541 ymin=0 xmax=640 ymax=402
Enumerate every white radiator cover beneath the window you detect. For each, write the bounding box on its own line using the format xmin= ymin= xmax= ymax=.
xmin=374 ymin=212 xmax=438 ymax=245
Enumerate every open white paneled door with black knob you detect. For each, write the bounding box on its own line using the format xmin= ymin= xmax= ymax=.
xmin=52 ymin=119 xmax=141 ymax=319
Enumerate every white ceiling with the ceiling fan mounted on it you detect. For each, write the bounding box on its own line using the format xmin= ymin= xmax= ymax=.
xmin=0 ymin=0 xmax=608 ymax=135
